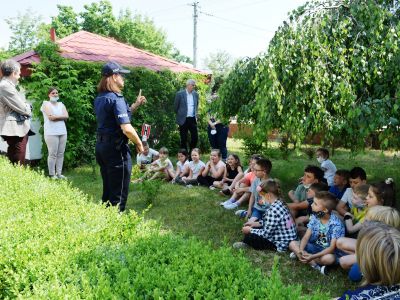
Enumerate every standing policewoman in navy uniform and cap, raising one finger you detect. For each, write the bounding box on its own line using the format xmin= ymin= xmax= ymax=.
xmin=94 ymin=62 xmax=146 ymax=212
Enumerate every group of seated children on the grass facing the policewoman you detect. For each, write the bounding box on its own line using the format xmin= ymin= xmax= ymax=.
xmin=133 ymin=148 xmax=400 ymax=299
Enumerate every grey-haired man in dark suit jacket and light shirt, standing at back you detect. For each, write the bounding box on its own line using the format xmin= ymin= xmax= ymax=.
xmin=174 ymin=79 xmax=199 ymax=151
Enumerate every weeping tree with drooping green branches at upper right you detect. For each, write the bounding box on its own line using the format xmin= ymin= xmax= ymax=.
xmin=217 ymin=0 xmax=400 ymax=150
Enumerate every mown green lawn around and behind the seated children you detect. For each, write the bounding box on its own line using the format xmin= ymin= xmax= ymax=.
xmin=66 ymin=140 xmax=400 ymax=297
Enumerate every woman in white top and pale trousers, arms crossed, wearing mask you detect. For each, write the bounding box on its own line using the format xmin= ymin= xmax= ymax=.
xmin=40 ymin=87 xmax=69 ymax=179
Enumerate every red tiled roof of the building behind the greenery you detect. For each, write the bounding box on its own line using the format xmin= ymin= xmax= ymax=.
xmin=14 ymin=31 xmax=206 ymax=74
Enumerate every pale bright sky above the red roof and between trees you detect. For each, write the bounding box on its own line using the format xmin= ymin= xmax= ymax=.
xmin=0 ymin=0 xmax=306 ymax=68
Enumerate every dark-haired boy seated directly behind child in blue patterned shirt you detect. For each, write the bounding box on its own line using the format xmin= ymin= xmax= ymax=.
xmin=288 ymin=166 xmax=325 ymax=204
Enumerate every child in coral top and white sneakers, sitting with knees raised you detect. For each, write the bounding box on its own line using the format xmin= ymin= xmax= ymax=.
xmin=220 ymin=154 xmax=261 ymax=211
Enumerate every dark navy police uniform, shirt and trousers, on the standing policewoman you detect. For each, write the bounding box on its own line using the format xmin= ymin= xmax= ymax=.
xmin=94 ymin=92 xmax=132 ymax=212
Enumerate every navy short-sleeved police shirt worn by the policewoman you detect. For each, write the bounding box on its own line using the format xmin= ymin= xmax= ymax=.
xmin=94 ymin=92 xmax=131 ymax=134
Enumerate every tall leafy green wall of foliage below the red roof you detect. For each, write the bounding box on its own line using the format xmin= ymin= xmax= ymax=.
xmin=21 ymin=43 xmax=209 ymax=168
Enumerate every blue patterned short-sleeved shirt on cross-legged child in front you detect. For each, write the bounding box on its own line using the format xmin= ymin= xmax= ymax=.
xmin=307 ymin=213 xmax=344 ymax=248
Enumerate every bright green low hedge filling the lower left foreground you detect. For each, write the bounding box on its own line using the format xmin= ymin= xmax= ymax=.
xmin=0 ymin=157 xmax=327 ymax=299
